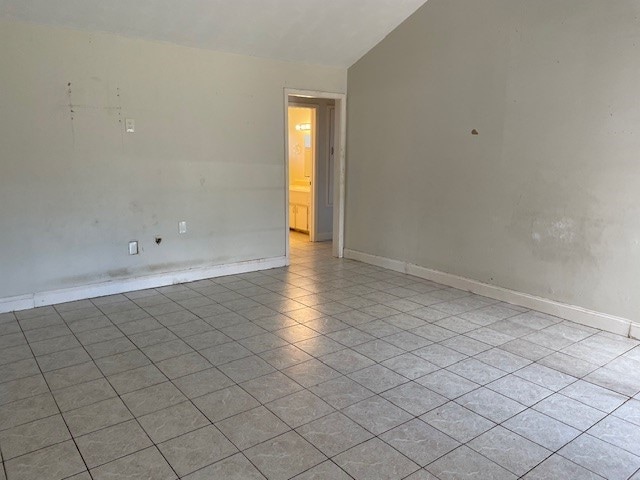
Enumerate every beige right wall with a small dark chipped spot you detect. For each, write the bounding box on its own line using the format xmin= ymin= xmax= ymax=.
xmin=346 ymin=0 xmax=640 ymax=322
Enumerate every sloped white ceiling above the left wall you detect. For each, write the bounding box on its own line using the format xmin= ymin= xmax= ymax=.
xmin=0 ymin=0 xmax=426 ymax=67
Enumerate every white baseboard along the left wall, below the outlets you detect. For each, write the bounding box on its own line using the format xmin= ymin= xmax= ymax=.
xmin=0 ymin=257 xmax=287 ymax=313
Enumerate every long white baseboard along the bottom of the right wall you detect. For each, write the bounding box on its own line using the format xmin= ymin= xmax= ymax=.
xmin=344 ymin=249 xmax=640 ymax=339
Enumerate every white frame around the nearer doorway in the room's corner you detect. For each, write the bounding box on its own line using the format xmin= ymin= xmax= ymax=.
xmin=284 ymin=88 xmax=347 ymax=265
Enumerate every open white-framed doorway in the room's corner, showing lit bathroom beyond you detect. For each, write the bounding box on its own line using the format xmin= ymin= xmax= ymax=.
xmin=284 ymin=89 xmax=346 ymax=260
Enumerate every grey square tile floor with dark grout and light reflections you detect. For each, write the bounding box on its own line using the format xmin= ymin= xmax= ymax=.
xmin=0 ymin=231 xmax=640 ymax=480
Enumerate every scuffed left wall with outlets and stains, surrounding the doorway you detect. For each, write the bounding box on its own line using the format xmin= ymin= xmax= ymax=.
xmin=0 ymin=22 xmax=346 ymax=303
